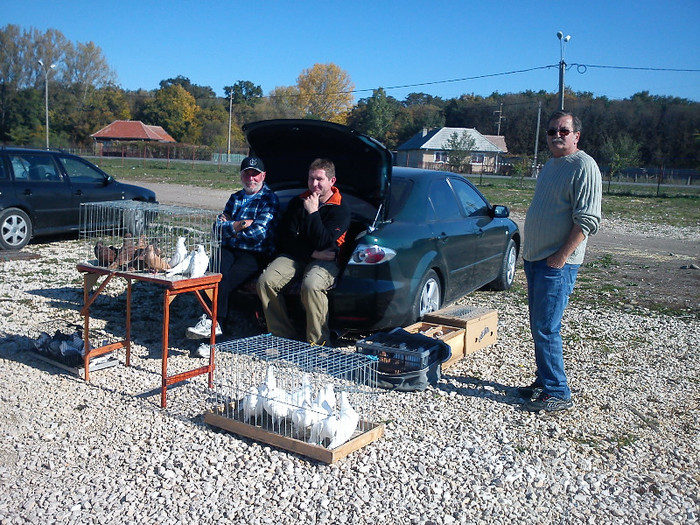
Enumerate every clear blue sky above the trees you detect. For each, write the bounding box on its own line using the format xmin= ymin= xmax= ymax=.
xmin=5 ymin=0 xmax=700 ymax=101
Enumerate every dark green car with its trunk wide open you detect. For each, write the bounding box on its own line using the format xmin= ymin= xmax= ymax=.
xmin=243 ymin=120 xmax=520 ymax=331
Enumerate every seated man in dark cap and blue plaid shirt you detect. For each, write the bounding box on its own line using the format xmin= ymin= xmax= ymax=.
xmin=186 ymin=157 xmax=279 ymax=348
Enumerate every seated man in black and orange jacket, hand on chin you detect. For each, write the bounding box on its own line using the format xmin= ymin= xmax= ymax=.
xmin=258 ymin=159 xmax=350 ymax=345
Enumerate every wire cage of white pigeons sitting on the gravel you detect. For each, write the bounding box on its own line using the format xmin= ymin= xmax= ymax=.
xmin=214 ymin=334 xmax=378 ymax=449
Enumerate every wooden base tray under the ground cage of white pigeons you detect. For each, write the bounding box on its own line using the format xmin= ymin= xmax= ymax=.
xmin=204 ymin=406 xmax=384 ymax=465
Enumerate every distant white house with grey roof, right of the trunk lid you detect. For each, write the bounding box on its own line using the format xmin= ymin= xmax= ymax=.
xmin=396 ymin=128 xmax=508 ymax=173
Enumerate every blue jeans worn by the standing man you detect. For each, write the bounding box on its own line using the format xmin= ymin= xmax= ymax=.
xmin=524 ymin=259 xmax=579 ymax=400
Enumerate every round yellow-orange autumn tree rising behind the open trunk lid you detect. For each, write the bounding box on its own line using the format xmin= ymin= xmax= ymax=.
xmin=297 ymin=63 xmax=355 ymax=124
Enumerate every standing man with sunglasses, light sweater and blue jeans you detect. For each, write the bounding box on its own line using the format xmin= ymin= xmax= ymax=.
xmin=519 ymin=111 xmax=602 ymax=412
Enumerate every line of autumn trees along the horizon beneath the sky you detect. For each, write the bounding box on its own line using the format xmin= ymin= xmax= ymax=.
xmin=0 ymin=25 xmax=700 ymax=169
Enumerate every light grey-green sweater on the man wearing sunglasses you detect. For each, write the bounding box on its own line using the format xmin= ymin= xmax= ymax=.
xmin=523 ymin=150 xmax=602 ymax=264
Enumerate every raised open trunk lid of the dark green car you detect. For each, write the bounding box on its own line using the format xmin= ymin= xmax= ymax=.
xmin=243 ymin=119 xmax=392 ymax=208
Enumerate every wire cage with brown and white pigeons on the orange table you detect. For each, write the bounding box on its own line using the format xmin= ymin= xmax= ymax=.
xmin=80 ymin=200 xmax=221 ymax=280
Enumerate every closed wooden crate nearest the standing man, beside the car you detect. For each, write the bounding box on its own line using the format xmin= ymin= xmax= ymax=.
xmin=423 ymin=306 xmax=498 ymax=355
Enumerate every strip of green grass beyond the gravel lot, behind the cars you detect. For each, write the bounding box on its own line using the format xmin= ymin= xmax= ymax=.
xmin=90 ymin=157 xmax=700 ymax=227
